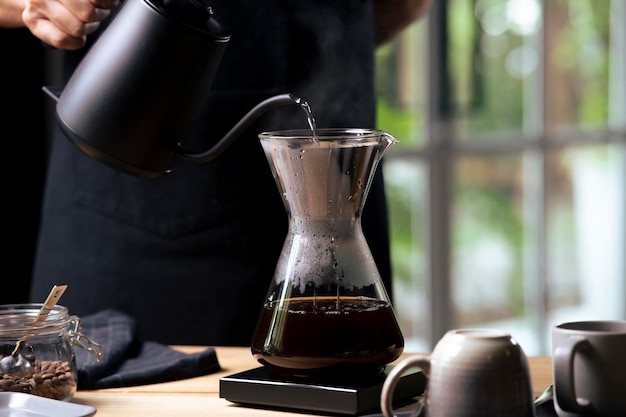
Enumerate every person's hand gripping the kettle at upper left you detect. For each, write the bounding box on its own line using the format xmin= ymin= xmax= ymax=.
xmin=22 ymin=0 xmax=118 ymax=50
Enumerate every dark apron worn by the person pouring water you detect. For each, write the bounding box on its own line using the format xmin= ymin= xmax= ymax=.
xmin=31 ymin=0 xmax=391 ymax=346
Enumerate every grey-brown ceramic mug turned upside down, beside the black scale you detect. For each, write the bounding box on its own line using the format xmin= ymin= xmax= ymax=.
xmin=380 ymin=329 xmax=535 ymax=417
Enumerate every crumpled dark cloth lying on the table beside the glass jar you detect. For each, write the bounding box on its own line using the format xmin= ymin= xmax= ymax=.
xmin=75 ymin=310 xmax=220 ymax=390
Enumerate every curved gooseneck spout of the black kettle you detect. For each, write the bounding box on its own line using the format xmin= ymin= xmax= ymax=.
xmin=174 ymin=94 xmax=311 ymax=163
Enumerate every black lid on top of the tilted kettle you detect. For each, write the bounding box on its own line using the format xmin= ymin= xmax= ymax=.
xmin=145 ymin=0 xmax=230 ymax=41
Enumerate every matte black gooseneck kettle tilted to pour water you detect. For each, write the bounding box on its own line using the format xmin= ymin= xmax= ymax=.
xmin=44 ymin=0 xmax=308 ymax=178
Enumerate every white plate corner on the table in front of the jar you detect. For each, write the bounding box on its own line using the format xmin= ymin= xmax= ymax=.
xmin=0 ymin=392 xmax=96 ymax=417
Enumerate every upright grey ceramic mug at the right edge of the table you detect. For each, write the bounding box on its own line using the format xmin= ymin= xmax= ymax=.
xmin=552 ymin=320 xmax=626 ymax=417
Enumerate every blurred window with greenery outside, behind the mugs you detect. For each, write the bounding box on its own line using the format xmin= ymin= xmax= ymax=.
xmin=377 ymin=0 xmax=626 ymax=355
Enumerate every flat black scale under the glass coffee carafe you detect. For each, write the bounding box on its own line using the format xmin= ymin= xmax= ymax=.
xmin=220 ymin=365 xmax=426 ymax=416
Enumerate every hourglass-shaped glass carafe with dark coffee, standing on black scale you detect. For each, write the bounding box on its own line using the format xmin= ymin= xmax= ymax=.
xmin=252 ymin=129 xmax=404 ymax=378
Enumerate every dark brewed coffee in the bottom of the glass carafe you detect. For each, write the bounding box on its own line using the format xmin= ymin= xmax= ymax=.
xmin=252 ymin=297 xmax=404 ymax=376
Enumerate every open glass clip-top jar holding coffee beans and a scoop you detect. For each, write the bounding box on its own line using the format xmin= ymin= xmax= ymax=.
xmin=0 ymin=304 xmax=102 ymax=401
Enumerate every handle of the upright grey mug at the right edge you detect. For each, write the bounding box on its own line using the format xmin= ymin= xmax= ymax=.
xmin=553 ymin=336 xmax=592 ymax=414
